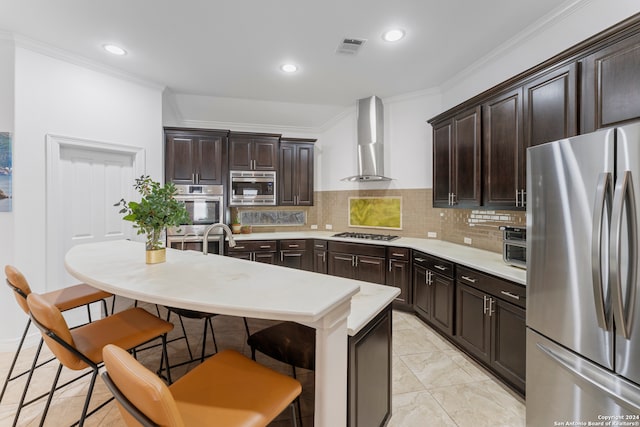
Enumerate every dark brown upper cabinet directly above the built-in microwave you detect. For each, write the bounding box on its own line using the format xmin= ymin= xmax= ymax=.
xmin=229 ymin=132 xmax=280 ymax=171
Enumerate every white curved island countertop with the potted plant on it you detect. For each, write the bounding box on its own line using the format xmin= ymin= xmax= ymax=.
xmin=65 ymin=241 xmax=399 ymax=335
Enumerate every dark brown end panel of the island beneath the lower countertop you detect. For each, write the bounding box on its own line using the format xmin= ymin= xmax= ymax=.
xmin=347 ymin=305 xmax=392 ymax=427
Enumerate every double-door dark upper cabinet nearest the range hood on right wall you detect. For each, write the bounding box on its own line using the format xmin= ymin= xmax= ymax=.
xmin=433 ymin=106 xmax=481 ymax=207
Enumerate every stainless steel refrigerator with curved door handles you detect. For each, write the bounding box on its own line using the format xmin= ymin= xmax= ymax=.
xmin=526 ymin=123 xmax=640 ymax=427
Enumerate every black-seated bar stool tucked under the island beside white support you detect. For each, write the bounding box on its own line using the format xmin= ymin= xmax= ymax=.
xmin=247 ymin=322 xmax=316 ymax=425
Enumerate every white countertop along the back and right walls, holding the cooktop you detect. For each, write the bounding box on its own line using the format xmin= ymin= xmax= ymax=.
xmin=233 ymin=231 xmax=527 ymax=285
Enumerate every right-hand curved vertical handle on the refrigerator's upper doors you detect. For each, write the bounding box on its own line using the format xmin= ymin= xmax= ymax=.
xmin=609 ymin=171 xmax=638 ymax=339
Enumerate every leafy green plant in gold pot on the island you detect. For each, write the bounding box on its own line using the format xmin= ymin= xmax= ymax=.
xmin=114 ymin=175 xmax=191 ymax=264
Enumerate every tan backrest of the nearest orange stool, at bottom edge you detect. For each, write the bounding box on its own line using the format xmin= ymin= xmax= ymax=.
xmin=102 ymin=344 xmax=184 ymax=427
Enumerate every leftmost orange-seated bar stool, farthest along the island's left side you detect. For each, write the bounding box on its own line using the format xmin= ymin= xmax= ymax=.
xmin=0 ymin=265 xmax=113 ymax=425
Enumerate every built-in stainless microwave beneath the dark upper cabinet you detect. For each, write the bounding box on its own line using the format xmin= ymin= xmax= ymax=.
xmin=229 ymin=171 xmax=276 ymax=206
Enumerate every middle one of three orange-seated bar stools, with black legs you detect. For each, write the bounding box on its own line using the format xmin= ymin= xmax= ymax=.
xmin=27 ymin=292 xmax=173 ymax=426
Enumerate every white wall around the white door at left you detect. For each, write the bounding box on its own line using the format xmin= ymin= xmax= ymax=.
xmin=0 ymin=47 xmax=163 ymax=350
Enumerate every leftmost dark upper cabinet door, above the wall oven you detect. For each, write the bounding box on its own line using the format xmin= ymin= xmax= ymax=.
xmin=165 ymin=134 xmax=196 ymax=184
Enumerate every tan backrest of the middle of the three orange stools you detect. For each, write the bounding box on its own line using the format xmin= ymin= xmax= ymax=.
xmin=27 ymin=292 xmax=89 ymax=371
